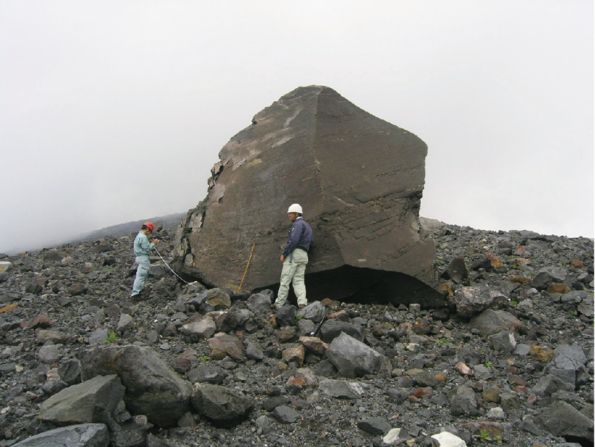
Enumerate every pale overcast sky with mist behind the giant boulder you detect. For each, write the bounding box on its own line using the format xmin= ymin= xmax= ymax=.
xmin=0 ymin=0 xmax=594 ymax=252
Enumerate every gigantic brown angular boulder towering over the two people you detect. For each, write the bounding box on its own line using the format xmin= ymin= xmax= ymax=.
xmin=175 ymin=86 xmax=442 ymax=306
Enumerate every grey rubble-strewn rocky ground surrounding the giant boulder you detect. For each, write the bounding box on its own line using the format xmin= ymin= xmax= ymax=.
xmin=0 ymin=222 xmax=594 ymax=447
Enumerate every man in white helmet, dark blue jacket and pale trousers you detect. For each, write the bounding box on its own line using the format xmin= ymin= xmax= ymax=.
xmin=272 ymin=203 xmax=314 ymax=309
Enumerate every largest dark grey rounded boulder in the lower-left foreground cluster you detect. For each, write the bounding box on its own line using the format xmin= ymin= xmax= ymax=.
xmin=81 ymin=346 xmax=192 ymax=427
